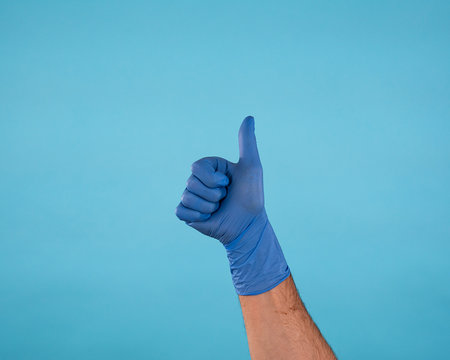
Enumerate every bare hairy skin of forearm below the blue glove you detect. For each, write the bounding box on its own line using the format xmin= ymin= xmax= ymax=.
xmin=239 ymin=276 xmax=336 ymax=360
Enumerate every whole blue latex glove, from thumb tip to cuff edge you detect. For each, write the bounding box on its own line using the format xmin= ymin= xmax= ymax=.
xmin=176 ymin=116 xmax=290 ymax=295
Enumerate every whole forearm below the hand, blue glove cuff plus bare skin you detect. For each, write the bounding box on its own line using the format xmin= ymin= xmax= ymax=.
xmin=225 ymin=211 xmax=335 ymax=360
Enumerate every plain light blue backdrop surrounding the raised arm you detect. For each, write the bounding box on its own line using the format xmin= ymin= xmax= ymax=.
xmin=0 ymin=1 xmax=450 ymax=359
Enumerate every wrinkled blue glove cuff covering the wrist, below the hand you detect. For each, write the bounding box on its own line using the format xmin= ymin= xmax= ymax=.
xmin=225 ymin=211 xmax=290 ymax=295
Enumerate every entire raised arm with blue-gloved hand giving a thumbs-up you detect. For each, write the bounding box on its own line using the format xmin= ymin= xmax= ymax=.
xmin=176 ymin=117 xmax=335 ymax=360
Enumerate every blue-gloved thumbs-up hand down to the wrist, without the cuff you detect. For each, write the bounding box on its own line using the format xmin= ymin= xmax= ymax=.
xmin=176 ymin=116 xmax=264 ymax=245
